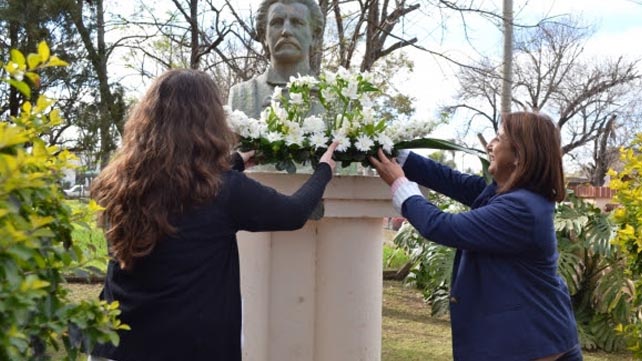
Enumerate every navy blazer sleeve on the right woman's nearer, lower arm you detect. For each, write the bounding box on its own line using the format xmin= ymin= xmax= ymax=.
xmin=402 ymin=193 xmax=536 ymax=254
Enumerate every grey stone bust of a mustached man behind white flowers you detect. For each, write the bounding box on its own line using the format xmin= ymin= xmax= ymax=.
xmin=228 ymin=0 xmax=325 ymax=119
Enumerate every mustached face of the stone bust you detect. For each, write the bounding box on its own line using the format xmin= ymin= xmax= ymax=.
xmin=266 ymin=3 xmax=312 ymax=63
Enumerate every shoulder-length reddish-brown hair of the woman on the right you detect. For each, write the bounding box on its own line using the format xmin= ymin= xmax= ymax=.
xmin=499 ymin=112 xmax=565 ymax=202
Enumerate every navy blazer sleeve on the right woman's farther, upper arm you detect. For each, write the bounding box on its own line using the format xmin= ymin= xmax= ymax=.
xmin=403 ymin=152 xmax=487 ymax=207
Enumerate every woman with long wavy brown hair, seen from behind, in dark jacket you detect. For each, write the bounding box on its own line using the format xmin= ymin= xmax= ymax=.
xmin=91 ymin=69 xmax=336 ymax=361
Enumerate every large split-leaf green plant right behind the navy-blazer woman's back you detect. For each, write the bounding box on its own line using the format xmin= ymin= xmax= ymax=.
xmin=555 ymin=193 xmax=634 ymax=352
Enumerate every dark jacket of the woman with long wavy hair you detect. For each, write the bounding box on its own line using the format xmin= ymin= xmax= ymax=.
xmin=91 ymin=163 xmax=332 ymax=361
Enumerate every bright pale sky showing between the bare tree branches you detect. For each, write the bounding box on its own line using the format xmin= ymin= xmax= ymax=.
xmin=107 ymin=0 xmax=642 ymax=169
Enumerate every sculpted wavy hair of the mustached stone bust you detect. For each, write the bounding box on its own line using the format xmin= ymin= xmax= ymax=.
xmin=255 ymin=0 xmax=325 ymax=56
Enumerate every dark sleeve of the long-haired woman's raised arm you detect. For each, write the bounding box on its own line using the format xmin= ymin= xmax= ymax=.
xmin=229 ymin=163 xmax=332 ymax=232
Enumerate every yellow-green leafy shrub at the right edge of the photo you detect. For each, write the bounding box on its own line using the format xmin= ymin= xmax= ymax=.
xmin=609 ymin=133 xmax=642 ymax=359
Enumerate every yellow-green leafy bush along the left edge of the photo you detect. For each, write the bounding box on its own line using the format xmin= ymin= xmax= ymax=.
xmin=0 ymin=42 xmax=127 ymax=360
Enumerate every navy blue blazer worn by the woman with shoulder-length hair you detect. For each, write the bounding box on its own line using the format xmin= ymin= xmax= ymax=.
xmin=402 ymin=153 xmax=578 ymax=361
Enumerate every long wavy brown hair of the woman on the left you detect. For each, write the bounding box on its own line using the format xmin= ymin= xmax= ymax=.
xmin=91 ymin=69 xmax=235 ymax=269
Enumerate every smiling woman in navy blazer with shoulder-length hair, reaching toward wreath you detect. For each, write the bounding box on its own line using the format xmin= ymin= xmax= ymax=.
xmin=370 ymin=112 xmax=582 ymax=361
